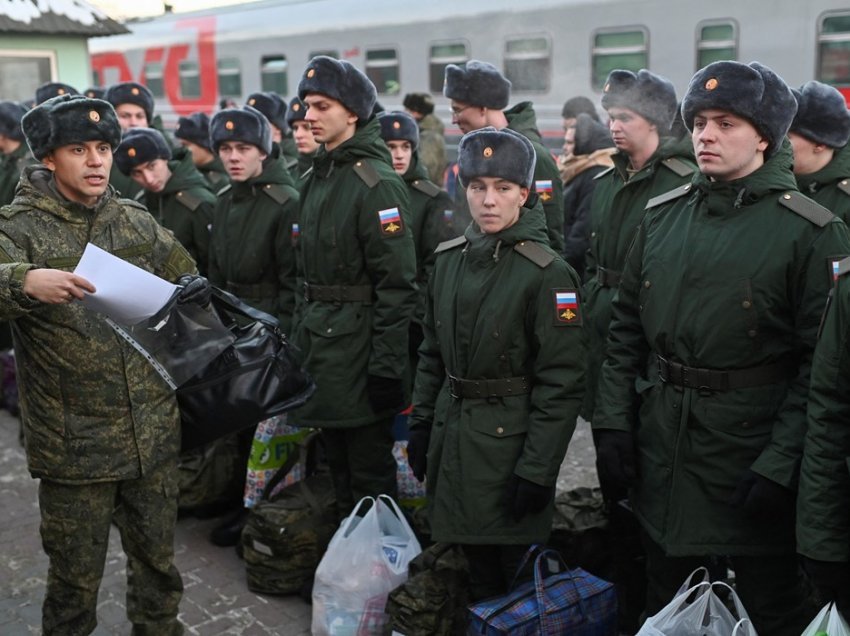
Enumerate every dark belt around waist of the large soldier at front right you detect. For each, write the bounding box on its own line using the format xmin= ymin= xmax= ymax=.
xmin=656 ymin=355 xmax=797 ymax=391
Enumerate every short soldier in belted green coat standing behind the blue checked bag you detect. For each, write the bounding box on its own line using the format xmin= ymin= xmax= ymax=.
xmin=408 ymin=127 xmax=586 ymax=599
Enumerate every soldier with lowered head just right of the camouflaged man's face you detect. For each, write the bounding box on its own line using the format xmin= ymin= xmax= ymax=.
xmin=115 ymin=128 xmax=216 ymax=274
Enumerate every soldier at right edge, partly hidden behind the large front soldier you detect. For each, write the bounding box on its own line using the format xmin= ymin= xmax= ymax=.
xmin=788 ymin=81 xmax=850 ymax=223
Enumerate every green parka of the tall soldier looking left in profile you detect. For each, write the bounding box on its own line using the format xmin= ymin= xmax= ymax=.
xmin=293 ymin=117 xmax=417 ymax=428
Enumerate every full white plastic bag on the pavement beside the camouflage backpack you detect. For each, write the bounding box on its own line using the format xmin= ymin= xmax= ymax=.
xmin=312 ymin=495 xmax=422 ymax=636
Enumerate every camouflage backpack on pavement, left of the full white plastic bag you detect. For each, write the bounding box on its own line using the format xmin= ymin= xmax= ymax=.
xmin=242 ymin=432 xmax=338 ymax=594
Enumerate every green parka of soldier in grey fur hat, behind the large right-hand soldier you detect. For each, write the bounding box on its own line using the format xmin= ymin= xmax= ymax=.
xmin=582 ymin=138 xmax=696 ymax=420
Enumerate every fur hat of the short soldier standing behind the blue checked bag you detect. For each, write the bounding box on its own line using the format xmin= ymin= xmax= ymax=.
xmin=457 ymin=126 xmax=537 ymax=188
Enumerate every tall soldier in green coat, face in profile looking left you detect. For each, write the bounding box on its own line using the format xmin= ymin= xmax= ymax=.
xmin=293 ymin=56 xmax=417 ymax=516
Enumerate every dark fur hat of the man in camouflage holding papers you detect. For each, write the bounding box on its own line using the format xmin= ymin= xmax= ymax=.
xmin=21 ymin=95 xmax=121 ymax=160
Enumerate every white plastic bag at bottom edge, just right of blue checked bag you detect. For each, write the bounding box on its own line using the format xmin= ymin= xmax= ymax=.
xmin=637 ymin=568 xmax=757 ymax=636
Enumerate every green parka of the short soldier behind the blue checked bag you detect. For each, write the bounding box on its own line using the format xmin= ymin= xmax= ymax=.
xmin=411 ymin=204 xmax=586 ymax=545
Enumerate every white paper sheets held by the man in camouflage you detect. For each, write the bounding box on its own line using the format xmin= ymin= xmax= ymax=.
xmin=74 ymin=243 xmax=177 ymax=325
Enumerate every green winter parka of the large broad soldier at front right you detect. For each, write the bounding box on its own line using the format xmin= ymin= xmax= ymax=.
xmin=593 ymin=142 xmax=850 ymax=556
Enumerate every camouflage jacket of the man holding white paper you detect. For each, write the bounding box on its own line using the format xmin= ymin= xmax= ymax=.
xmin=0 ymin=166 xmax=195 ymax=483
